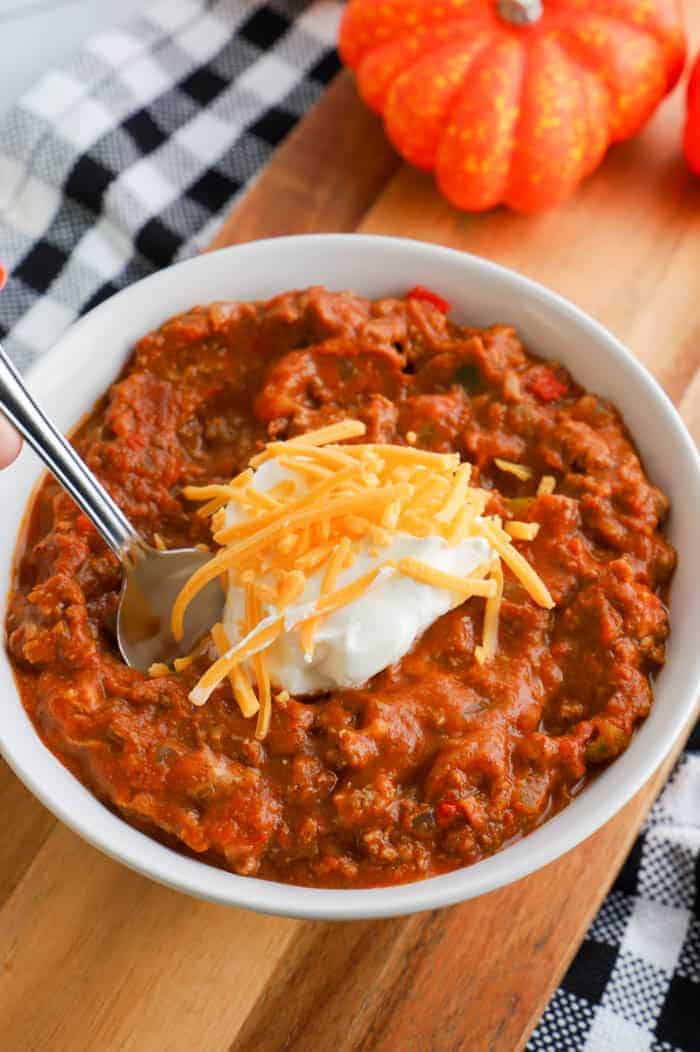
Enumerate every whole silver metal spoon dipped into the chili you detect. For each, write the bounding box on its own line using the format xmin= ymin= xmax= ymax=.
xmin=0 ymin=347 xmax=223 ymax=671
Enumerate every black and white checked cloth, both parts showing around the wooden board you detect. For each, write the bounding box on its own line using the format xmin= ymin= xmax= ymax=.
xmin=0 ymin=0 xmax=700 ymax=1052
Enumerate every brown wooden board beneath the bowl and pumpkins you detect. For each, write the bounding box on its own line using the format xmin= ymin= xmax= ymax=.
xmin=0 ymin=20 xmax=700 ymax=1052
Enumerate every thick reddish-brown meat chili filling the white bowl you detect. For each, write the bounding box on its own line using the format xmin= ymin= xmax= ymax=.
xmin=6 ymin=288 xmax=675 ymax=888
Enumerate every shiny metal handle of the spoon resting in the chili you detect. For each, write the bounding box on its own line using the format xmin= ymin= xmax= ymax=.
xmin=0 ymin=347 xmax=143 ymax=562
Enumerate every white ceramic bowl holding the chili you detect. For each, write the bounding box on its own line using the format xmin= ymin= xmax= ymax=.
xmin=0 ymin=236 xmax=700 ymax=919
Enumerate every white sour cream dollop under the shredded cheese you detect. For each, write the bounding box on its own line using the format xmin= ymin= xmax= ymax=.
xmin=223 ymin=460 xmax=495 ymax=694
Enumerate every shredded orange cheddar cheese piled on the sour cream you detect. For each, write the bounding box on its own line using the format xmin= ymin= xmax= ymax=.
xmin=173 ymin=420 xmax=554 ymax=739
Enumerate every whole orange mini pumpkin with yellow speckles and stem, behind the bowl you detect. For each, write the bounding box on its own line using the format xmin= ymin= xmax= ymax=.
xmin=340 ymin=0 xmax=685 ymax=211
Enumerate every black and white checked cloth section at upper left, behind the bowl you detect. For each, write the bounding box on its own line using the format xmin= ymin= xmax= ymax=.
xmin=0 ymin=0 xmax=341 ymax=366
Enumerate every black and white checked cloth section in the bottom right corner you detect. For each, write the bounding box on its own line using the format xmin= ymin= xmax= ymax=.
xmin=530 ymin=726 xmax=700 ymax=1052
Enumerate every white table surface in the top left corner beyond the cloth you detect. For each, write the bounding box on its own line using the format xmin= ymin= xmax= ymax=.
xmin=0 ymin=0 xmax=149 ymax=113
